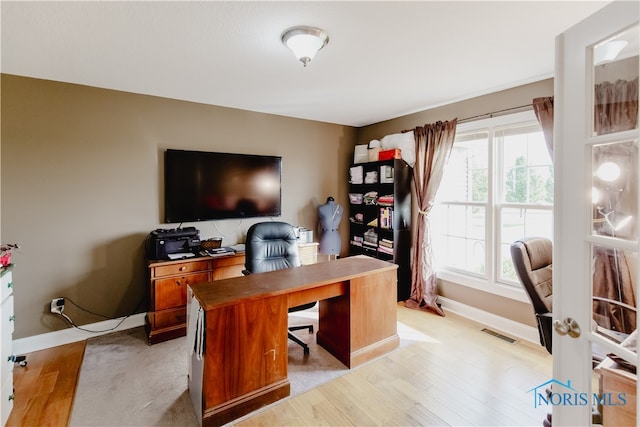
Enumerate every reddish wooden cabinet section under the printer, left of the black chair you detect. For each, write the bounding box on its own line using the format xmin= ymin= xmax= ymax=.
xmin=145 ymin=254 xmax=244 ymax=345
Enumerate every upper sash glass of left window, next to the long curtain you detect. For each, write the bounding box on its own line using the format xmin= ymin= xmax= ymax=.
xmin=437 ymin=132 xmax=489 ymax=202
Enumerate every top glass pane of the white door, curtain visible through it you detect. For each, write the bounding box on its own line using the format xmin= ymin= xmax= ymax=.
xmin=593 ymin=25 xmax=639 ymax=135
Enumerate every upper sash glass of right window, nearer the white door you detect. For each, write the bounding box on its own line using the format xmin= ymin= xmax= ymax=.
xmin=496 ymin=126 xmax=553 ymax=205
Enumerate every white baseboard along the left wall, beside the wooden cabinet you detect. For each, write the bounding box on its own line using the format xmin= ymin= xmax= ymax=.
xmin=13 ymin=313 xmax=146 ymax=355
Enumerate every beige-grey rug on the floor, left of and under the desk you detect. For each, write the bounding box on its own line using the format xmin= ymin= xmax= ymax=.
xmin=69 ymin=311 xmax=356 ymax=426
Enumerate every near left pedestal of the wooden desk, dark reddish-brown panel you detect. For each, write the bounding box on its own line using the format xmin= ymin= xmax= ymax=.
xmin=202 ymin=295 xmax=290 ymax=425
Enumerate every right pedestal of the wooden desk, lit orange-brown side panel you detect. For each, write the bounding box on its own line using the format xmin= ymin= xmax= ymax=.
xmin=316 ymin=270 xmax=400 ymax=368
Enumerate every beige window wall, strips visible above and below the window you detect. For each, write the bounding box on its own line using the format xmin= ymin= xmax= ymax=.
xmin=358 ymin=79 xmax=553 ymax=327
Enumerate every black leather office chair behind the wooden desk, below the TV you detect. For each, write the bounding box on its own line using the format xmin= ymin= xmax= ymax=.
xmin=245 ymin=221 xmax=316 ymax=354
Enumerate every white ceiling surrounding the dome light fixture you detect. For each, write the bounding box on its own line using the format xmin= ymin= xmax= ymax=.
xmin=0 ymin=0 xmax=609 ymax=126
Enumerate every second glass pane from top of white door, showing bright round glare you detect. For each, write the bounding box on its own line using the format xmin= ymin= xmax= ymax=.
xmin=591 ymin=141 xmax=638 ymax=240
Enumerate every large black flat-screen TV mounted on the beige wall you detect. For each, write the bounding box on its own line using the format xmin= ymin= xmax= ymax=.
xmin=164 ymin=149 xmax=282 ymax=223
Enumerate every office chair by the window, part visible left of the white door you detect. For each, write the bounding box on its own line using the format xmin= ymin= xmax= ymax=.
xmin=511 ymin=237 xmax=553 ymax=354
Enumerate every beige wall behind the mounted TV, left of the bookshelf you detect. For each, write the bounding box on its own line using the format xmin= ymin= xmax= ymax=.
xmin=0 ymin=75 xmax=356 ymax=338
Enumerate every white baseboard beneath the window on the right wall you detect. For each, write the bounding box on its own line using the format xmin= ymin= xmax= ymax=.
xmin=438 ymin=297 xmax=540 ymax=344
